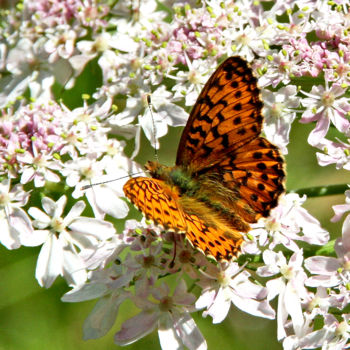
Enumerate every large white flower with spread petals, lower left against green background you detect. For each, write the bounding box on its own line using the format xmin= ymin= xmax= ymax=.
xmin=27 ymin=196 xmax=115 ymax=288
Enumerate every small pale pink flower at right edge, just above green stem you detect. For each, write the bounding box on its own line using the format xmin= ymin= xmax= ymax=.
xmin=316 ymin=139 xmax=350 ymax=170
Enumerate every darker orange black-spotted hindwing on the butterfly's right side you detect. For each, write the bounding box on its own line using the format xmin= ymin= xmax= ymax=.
xmin=215 ymin=137 xmax=285 ymax=223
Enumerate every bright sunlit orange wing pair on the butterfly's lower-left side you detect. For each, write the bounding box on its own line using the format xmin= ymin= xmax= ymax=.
xmin=124 ymin=177 xmax=243 ymax=260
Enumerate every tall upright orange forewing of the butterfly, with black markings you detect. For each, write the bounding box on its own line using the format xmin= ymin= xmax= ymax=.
xmin=176 ymin=57 xmax=263 ymax=170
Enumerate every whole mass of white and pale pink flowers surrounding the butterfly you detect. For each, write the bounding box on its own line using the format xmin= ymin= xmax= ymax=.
xmin=0 ymin=0 xmax=350 ymax=350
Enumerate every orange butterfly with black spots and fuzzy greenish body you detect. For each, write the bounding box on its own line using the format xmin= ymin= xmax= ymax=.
xmin=124 ymin=57 xmax=285 ymax=261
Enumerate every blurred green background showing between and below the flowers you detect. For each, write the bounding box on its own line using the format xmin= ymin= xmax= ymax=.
xmin=0 ymin=118 xmax=348 ymax=350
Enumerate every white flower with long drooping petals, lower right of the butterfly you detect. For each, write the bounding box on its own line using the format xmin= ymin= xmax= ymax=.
xmin=257 ymin=250 xmax=307 ymax=340
